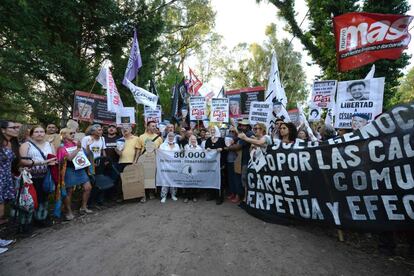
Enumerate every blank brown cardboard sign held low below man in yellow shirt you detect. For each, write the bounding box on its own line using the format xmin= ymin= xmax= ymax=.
xmin=121 ymin=164 xmax=145 ymax=200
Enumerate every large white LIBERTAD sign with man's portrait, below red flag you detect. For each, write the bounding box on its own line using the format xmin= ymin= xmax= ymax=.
xmin=335 ymin=78 xmax=384 ymax=128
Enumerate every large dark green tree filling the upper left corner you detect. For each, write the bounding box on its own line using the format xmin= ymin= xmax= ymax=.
xmin=0 ymin=0 xmax=167 ymax=123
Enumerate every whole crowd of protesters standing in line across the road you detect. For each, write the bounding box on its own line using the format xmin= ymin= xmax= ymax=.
xmin=0 ymin=115 xmax=410 ymax=253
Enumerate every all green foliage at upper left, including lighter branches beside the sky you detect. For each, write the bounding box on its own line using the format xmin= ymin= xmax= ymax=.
xmin=0 ymin=0 xmax=214 ymax=127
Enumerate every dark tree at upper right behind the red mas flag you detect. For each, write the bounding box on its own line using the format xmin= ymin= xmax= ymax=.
xmin=257 ymin=0 xmax=409 ymax=110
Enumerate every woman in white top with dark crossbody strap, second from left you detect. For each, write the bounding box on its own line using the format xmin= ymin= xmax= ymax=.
xmin=19 ymin=125 xmax=56 ymax=226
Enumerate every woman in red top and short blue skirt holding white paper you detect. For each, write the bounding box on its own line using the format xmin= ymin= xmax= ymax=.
xmin=57 ymin=128 xmax=92 ymax=220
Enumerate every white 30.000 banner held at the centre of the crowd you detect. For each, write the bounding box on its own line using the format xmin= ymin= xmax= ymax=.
xmin=156 ymin=149 xmax=221 ymax=189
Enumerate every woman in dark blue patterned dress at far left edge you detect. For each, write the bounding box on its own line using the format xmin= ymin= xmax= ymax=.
xmin=0 ymin=121 xmax=20 ymax=225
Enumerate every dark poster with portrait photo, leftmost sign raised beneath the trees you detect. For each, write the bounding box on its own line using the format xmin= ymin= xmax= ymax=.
xmin=72 ymin=91 xmax=116 ymax=124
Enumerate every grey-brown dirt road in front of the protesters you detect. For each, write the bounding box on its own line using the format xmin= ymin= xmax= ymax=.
xmin=0 ymin=199 xmax=410 ymax=276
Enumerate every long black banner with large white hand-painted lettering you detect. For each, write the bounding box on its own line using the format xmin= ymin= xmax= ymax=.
xmin=245 ymin=103 xmax=414 ymax=231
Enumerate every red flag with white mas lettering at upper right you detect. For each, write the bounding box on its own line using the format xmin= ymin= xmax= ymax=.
xmin=333 ymin=12 xmax=413 ymax=72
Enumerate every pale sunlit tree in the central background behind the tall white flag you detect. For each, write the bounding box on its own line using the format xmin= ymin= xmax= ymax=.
xmin=221 ymin=24 xmax=307 ymax=107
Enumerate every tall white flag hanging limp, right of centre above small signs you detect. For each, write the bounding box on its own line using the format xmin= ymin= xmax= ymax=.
xmin=265 ymin=53 xmax=287 ymax=107
